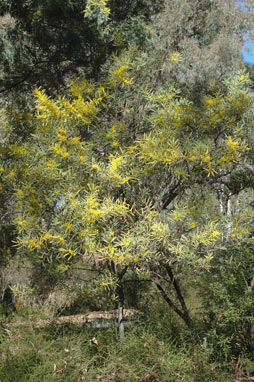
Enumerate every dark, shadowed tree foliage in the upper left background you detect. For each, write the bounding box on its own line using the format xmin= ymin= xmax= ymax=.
xmin=0 ymin=0 xmax=163 ymax=97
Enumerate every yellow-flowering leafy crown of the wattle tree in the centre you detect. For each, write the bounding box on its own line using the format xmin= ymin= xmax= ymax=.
xmin=2 ymin=49 xmax=253 ymax=328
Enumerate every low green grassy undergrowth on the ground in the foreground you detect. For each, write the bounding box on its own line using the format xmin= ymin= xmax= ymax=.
xmin=0 ymin=327 xmax=232 ymax=382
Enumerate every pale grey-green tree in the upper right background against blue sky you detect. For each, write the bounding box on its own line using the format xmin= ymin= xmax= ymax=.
xmin=149 ymin=0 xmax=254 ymax=101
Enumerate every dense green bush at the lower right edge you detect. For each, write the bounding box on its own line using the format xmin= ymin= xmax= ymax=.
xmin=199 ymin=246 xmax=254 ymax=359
